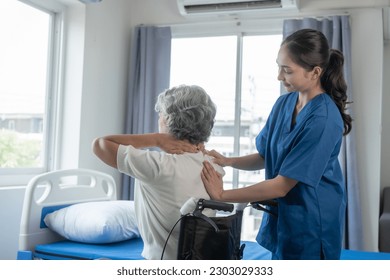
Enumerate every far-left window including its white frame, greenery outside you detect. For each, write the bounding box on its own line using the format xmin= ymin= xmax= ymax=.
xmin=0 ymin=0 xmax=61 ymax=185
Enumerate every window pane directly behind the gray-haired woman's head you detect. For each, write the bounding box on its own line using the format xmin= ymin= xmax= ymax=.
xmin=170 ymin=36 xmax=237 ymax=188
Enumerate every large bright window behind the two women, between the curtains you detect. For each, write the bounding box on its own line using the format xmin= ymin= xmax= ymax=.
xmin=170 ymin=34 xmax=282 ymax=240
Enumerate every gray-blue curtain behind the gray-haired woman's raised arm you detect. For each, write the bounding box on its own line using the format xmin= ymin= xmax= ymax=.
xmin=121 ymin=26 xmax=172 ymax=200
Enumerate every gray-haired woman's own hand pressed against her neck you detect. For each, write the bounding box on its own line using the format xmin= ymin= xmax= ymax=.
xmin=158 ymin=133 xmax=199 ymax=154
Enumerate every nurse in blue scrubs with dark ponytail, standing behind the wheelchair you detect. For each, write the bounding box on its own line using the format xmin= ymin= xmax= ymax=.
xmin=201 ymin=29 xmax=352 ymax=260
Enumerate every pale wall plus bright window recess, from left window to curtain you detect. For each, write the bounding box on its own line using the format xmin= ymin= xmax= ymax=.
xmin=58 ymin=0 xmax=131 ymax=186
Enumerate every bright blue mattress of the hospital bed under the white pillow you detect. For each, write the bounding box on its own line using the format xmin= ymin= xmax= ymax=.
xmin=34 ymin=238 xmax=390 ymax=260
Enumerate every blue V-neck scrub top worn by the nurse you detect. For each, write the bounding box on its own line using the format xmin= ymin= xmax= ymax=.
xmin=256 ymin=92 xmax=346 ymax=260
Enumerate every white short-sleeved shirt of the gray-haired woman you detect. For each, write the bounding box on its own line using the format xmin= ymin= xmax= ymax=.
xmin=117 ymin=145 xmax=225 ymax=260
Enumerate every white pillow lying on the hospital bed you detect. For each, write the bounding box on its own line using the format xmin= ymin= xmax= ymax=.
xmin=44 ymin=200 xmax=140 ymax=244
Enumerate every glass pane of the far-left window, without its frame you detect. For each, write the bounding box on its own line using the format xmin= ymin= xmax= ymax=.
xmin=0 ymin=0 xmax=50 ymax=168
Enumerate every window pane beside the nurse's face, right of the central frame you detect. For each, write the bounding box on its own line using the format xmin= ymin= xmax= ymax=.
xmin=239 ymin=35 xmax=282 ymax=187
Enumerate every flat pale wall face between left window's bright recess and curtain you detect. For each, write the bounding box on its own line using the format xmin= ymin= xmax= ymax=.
xmin=79 ymin=0 xmax=131 ymax=179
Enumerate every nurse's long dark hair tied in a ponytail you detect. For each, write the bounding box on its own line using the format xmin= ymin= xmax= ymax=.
xmin=282 ymin=29 xmax=352 ymax=135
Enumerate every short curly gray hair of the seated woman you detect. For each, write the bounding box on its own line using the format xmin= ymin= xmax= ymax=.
xmin=155 ymin=85 xmax=217 ymax=144
